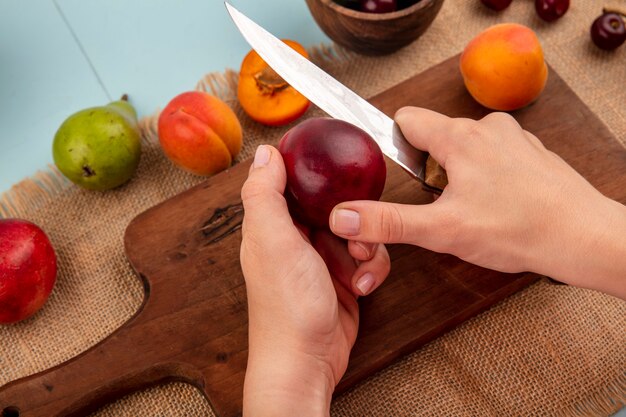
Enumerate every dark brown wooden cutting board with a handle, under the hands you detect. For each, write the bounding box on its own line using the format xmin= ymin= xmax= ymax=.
xmin=0 ymin=56 xmax=626 ymax=417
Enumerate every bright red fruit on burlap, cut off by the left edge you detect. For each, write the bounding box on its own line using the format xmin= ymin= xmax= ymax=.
xmin=0 ymin=219 xmax=57 ymax=323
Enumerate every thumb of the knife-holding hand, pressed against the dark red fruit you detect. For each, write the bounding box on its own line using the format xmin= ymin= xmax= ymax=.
xmin=329 ymin=201 xmax=440 ymax=248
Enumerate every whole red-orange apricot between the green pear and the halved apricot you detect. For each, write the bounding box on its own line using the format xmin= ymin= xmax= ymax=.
xmin=158 ymin=91 xmax=243 ymax=175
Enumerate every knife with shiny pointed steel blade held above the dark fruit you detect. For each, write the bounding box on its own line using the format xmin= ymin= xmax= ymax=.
xmin=224 ymin=2 xmax=432 ymax=184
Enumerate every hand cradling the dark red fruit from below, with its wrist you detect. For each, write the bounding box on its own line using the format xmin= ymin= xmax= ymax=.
xmin=241 ymin=145 xmax=390 ymax=417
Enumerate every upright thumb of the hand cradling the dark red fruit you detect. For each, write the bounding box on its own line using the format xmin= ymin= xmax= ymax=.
xmin=241 ymin=145 xmax=299 ymax=244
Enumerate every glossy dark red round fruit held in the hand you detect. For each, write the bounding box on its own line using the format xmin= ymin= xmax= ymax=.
xmin=278 ymin=118 xmax=387 ymax=228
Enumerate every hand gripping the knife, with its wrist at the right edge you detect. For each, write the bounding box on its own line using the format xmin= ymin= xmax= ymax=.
xmin=330 ymin=108 xmax=626 ymax=298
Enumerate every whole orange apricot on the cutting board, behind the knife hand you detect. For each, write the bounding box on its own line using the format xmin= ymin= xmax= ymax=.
xmin=461 ymin=23 xmax=548 ymax=111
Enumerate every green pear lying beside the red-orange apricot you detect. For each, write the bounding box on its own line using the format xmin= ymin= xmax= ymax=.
xmin=52 ymin=96 xmax=141 ymax=190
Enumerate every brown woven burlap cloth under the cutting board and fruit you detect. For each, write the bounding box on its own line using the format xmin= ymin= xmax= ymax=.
xmin=0 ymin=0 xmax=626 ymax=417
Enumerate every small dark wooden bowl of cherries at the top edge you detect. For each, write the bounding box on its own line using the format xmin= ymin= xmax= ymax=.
xmin=306 ymin=0 xmax=443 ymax=55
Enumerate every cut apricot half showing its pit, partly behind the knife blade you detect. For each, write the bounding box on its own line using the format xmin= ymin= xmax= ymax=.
xmin=237 ymin=40 xmax=310 ymax=126
